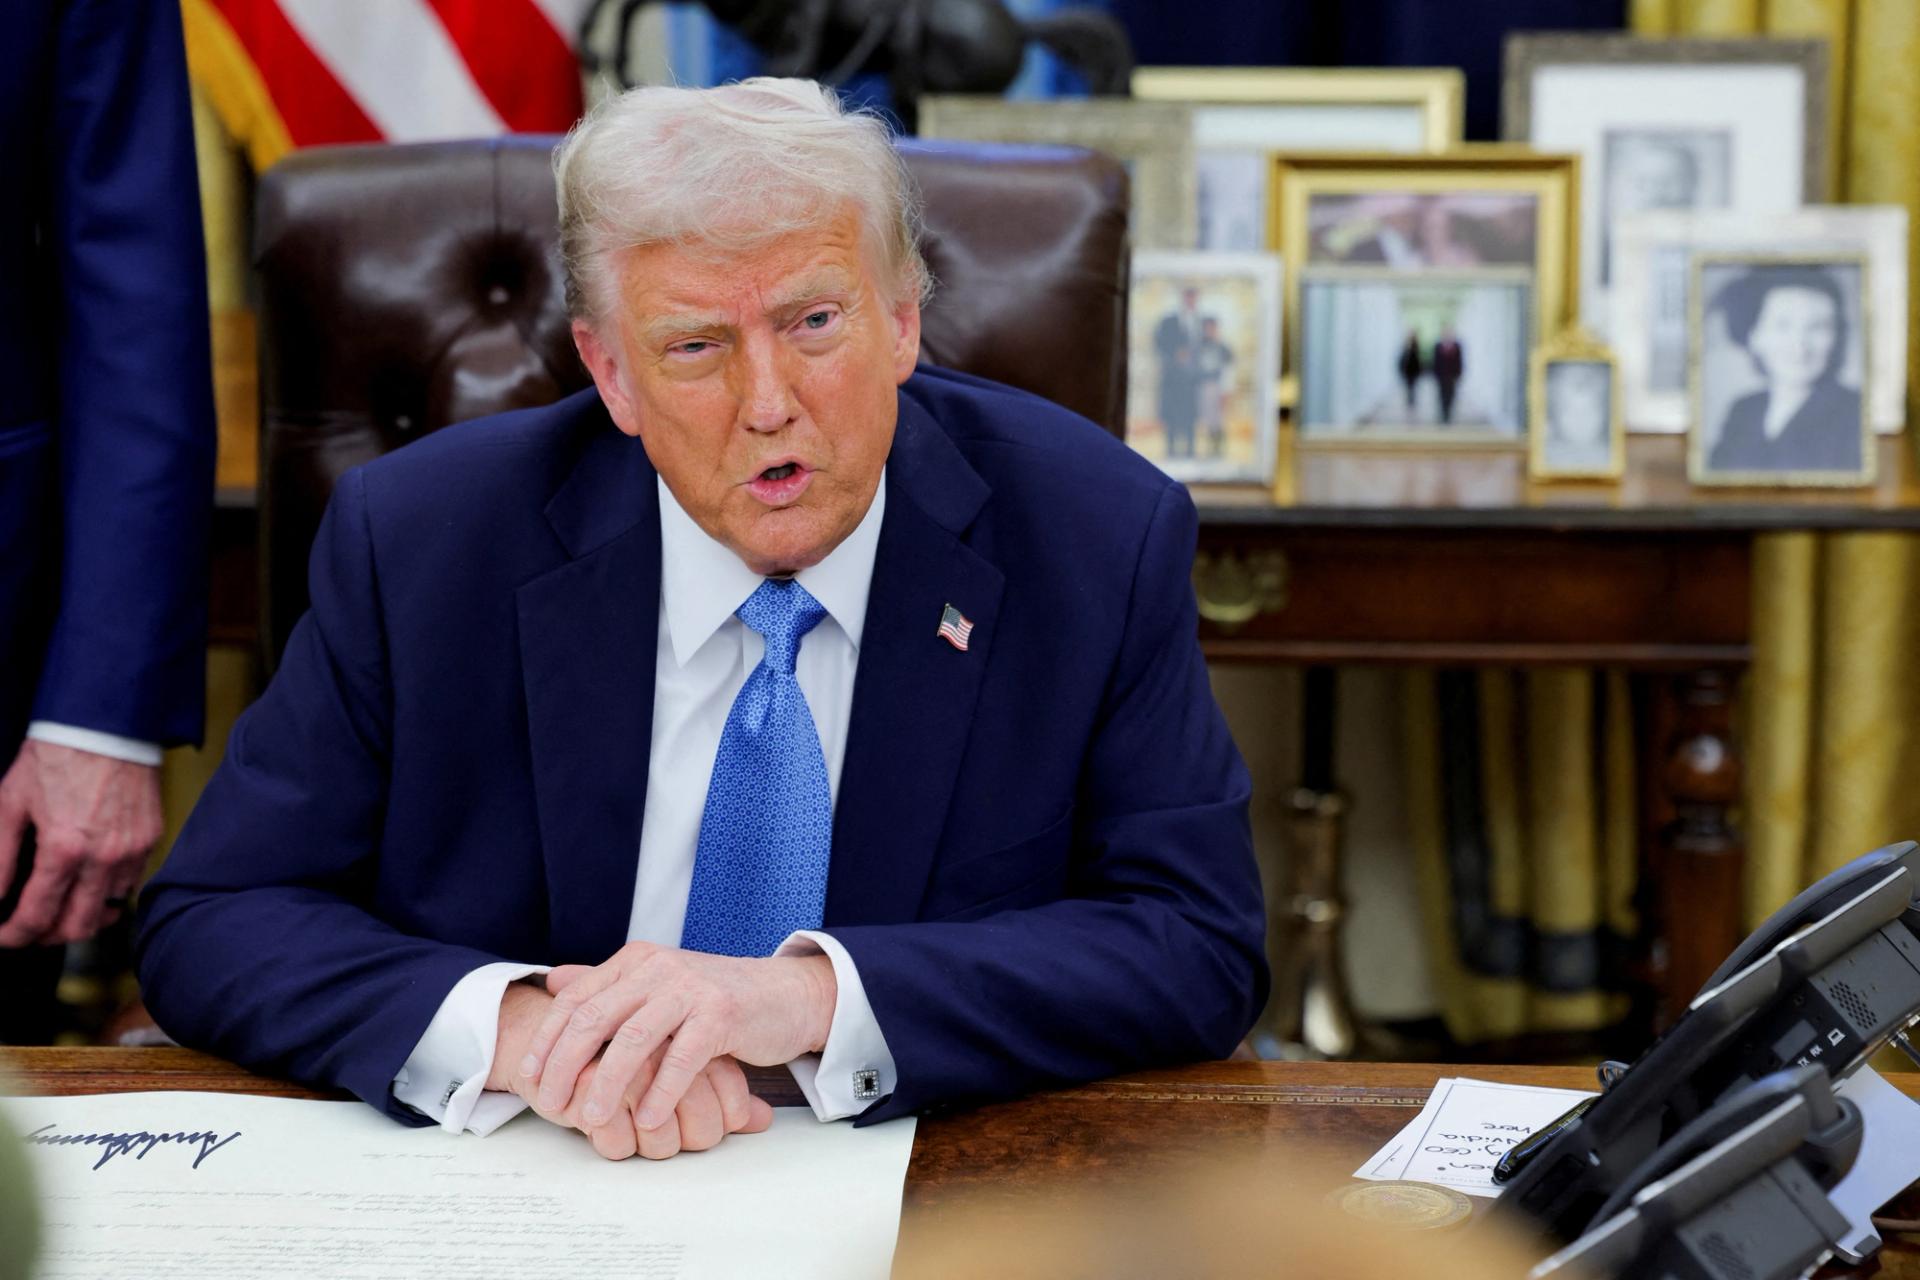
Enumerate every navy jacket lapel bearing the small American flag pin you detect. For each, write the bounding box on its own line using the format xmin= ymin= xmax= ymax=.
xmin=826 ymin=395 xmax=1006 ymax=925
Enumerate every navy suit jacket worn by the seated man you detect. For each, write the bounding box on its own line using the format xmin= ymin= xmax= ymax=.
xmin=138 ymin=368 xmax=1267 ymax=1121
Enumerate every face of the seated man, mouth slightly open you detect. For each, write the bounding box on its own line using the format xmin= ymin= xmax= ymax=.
xmin=574 ymin=209 xmax=920 ymax=574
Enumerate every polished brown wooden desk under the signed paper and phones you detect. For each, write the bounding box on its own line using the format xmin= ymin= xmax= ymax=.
xmin=11 ymin=1048 xmax=1920 ymax=1280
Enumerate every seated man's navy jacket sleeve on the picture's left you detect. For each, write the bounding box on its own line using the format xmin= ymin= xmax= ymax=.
xmin=138 ymin=472 xmax=501 ymax=1123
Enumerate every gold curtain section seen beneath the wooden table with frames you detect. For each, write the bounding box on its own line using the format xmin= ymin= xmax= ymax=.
xmin=1404 ymin=668 xmax=1640 ymax=1044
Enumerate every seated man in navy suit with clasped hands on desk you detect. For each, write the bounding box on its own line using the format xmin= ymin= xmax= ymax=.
xmin=140 ymin=81 xmax=1265 ymax=1159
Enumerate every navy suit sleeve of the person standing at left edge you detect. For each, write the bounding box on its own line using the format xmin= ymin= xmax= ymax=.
xmin=33 ymin=0 xmax=213 ymax=743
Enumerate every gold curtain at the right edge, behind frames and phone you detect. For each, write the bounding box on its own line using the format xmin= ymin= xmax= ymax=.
xmin=1632 ymin=0 xmax=1920 ymax=925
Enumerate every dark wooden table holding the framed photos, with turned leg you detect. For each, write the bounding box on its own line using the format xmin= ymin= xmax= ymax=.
xmin=1194 ymin=436 xmax=1920 ymax=1009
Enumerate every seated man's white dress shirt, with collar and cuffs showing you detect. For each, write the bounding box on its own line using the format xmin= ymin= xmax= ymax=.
xmin=394 ymin=476 xmax=895 ymax=1134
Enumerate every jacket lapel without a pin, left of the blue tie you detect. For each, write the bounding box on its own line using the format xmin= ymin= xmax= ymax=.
xmin=516 ymin=416 xmax=660 ymax=963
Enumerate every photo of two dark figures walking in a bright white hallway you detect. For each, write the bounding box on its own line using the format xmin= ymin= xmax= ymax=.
xmin=1300 ymin=276 xmax=1532 ymax=443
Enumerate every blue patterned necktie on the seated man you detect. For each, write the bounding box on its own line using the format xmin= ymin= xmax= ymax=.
xmin=680 ymin=578 xmax=833 ymax=956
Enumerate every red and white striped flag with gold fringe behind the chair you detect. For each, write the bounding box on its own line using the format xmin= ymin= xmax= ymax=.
xmin=180 ymin=0 xmax=589 ymax=169
